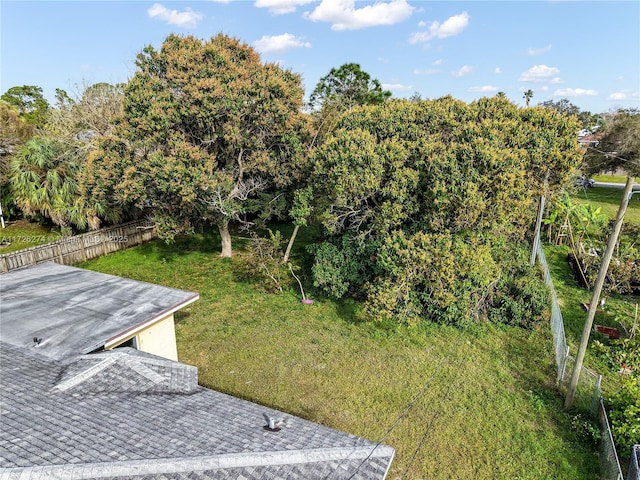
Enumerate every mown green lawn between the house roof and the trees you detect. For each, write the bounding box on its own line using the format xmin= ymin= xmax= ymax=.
xmin=82 ymin=231 xmax=599 ymax=480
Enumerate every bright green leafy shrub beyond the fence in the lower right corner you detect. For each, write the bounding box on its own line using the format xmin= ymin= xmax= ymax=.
xmin=607 ymin=376 xmax=640 ymax=458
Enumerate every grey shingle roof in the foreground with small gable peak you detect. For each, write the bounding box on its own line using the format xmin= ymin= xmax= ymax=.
xmin=0 ymin=264 xmax=394 ymax=480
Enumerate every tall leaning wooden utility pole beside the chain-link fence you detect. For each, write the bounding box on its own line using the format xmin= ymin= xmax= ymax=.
xmin=564 ymin=177 xmax=634 ymax=408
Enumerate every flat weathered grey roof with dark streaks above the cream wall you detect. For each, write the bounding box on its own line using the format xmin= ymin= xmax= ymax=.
xmin=0 ymin=262 xmax=199 ymax=360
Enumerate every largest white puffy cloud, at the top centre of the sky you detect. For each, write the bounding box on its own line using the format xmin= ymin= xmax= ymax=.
xmin=305 ymin=0 xmax=414 ymax=30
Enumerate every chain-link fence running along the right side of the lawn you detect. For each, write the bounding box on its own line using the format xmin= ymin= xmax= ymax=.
xmin=536 ymin=241 xmax=624 ymax=480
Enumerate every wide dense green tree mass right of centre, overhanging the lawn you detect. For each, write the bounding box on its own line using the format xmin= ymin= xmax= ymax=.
xmin=312 ymin=97 xmax=580 ymax=322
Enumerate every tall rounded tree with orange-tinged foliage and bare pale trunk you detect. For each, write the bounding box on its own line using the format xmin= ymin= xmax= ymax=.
xmin=83 ymin=34 xmax=306 ymax=257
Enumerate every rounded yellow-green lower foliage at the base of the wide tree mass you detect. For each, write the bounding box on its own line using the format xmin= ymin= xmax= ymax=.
xmin=366 ymin=232 xmax=499 ymax=325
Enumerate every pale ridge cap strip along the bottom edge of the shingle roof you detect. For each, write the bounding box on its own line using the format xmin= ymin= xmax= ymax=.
xmin=0 ymin=445 xmax=395 ymax=480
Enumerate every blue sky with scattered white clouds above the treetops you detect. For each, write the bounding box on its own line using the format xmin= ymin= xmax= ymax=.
xmin=0 ymin=0 xmax=640 ymax=113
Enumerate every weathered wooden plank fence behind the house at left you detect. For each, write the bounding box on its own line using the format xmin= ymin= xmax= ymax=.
xmin=0 ymin=220 xmax=155 ymax=273
